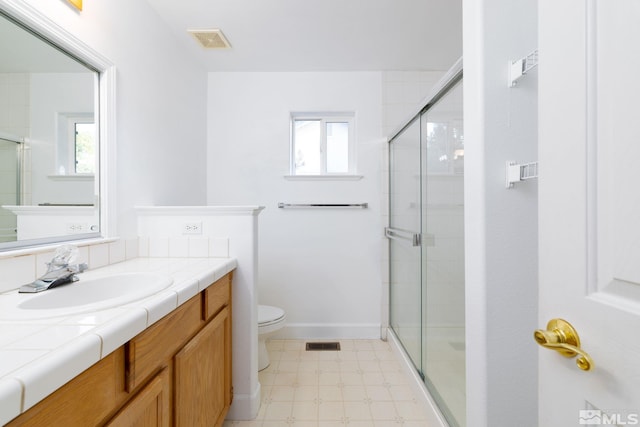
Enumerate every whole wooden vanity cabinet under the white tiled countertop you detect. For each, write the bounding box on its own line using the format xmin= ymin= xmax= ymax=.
xmin=6 ymin=273 xmax=233 ymax=427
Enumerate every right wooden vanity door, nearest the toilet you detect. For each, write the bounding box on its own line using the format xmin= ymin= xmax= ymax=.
xmin=174 ymin=307 xmax=231 ymax=427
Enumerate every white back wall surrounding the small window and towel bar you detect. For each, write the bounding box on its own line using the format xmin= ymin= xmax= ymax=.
xmin=207 ymin=72 xmax=384 ymax=338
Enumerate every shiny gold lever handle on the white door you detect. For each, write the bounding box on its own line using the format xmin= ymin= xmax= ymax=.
xmin=533 ymin=319 xmax=594 ymax=371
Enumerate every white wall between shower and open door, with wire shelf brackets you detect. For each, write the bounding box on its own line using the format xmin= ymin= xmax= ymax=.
xmin=463 ymin=0 xmax=539 ymax=427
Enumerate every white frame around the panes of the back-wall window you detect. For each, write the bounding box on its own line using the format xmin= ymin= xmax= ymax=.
xmin=289 ymin=112 xmax=357 ymax=178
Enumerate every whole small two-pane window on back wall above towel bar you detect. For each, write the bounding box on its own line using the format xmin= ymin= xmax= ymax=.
xmin=291 ymin=113 xmax=356 ymax=175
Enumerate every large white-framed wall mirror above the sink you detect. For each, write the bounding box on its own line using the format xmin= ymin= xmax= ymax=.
xmin=0 ymin=3 xmax=114 ymax=250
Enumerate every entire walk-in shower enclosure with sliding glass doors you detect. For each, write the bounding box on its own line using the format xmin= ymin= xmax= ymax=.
xmin=385 ymin=63 xmax=466 ymax=426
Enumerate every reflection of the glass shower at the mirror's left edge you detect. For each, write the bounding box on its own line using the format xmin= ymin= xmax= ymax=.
xmin=0 ymin=134 xmax=24 ymax=243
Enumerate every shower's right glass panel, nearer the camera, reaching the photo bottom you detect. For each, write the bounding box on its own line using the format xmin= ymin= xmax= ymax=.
xmin=421 ymin=83 xmax=466 ymax=425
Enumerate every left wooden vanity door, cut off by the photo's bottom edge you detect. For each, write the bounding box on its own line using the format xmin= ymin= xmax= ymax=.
xmin=106 ymin=368 xmax=171 ymax=427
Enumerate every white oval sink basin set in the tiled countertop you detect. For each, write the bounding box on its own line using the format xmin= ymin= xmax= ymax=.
xmin=0 ymin=273 xmax=173 ymax=320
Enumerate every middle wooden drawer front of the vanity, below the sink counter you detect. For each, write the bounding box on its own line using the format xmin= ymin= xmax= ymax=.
xmin=125 ymin=294 xmax=204 ymax=391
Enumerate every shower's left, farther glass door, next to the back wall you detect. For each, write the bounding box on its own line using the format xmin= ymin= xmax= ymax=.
xmin=386 ymin=119 xmax=423 ymax=373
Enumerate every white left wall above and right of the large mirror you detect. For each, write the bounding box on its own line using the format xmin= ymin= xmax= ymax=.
xmin=19 ymin=0 xmax=207 ymax=236
